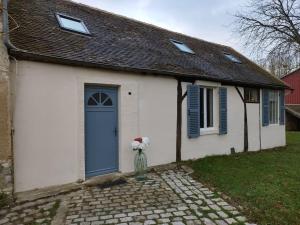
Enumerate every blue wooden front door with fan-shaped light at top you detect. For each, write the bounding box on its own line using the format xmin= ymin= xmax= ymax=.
xmin=85 ymin=86 xmax=118 ymax=177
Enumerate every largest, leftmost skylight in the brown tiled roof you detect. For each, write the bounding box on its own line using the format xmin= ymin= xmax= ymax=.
xmin=57 ymin=14 xmax=90 ymax=34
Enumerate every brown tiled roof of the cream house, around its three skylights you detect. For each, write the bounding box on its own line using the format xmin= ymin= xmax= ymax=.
xmin=9 ymin=0 xmax=285 ymax=88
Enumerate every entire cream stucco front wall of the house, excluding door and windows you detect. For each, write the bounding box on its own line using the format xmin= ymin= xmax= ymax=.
xmin=14 ymin=61 xmax=285 ymax=192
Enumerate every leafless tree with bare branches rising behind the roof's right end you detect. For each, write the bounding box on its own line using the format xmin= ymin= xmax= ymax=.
xmin=235 ymin=0 xmax=300 ymax=76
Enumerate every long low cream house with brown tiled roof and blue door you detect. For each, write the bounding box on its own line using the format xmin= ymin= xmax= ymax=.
xmin=3 ymin=0 xmax=286 ymax=192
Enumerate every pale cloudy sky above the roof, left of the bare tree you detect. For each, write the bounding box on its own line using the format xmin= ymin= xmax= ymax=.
xmin=74 ymin=0 xmax=248 ymax=54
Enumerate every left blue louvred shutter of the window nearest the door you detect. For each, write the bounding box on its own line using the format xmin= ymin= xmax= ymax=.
xmin=187 ymin=85 xmax=200 ymax=138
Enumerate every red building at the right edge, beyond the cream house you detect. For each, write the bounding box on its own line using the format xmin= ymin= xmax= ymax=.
xmin=281 ymin=68 xmax=300 ymax=131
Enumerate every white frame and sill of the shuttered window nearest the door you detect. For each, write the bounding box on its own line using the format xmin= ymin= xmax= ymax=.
xmin=199 ymin=86 xmax=217 ymax=132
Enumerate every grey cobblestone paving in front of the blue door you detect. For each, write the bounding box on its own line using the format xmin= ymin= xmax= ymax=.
xmin=0 ymin=170 xmax=258 ymax=225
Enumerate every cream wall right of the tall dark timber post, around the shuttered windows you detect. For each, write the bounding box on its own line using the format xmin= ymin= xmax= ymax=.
xmin=182 ymin=81 xmax=285 ymax=160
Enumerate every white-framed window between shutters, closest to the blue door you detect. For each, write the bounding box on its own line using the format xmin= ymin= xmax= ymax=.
xmin=200 ymin=87 xmax=214 ymax=129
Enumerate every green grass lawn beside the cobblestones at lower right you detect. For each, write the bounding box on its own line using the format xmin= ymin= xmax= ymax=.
xmin=189 ymin=132 xmax=300 ymax=225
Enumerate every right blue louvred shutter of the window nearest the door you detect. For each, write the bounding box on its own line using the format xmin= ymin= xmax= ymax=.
xmin=219 ymin=87 xmax=227 ymax=135
